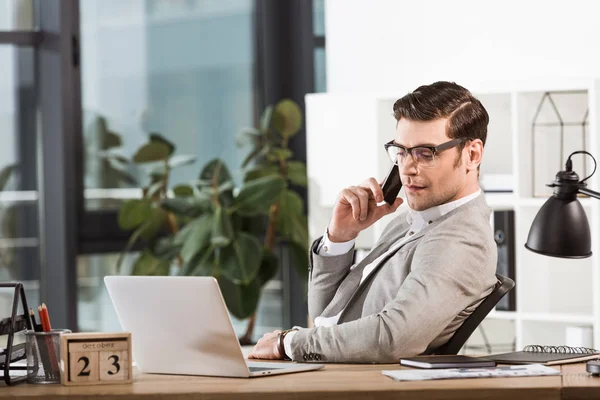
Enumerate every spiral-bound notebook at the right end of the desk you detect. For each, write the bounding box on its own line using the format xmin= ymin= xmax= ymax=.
xmin=482 ymin=345 xmax=600 ymax=365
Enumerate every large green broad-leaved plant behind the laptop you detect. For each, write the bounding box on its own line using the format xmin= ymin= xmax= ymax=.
xmin=111 ymin=99 xmax=308 ymax=344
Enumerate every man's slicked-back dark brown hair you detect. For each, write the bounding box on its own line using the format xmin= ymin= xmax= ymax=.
xmin=394 ymin=81 xmax=490 ymax=150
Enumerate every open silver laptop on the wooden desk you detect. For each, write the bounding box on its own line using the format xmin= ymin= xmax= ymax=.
xmin=104 ymin=276 xmax=324 ymax=378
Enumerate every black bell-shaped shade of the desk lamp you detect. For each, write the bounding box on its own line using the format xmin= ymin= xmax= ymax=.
xmin=525 ymin=196 xmax=592 ymax=258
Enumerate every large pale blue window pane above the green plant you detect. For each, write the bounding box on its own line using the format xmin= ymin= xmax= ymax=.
xmin=80 ymin=0 xmax=254 ymax=210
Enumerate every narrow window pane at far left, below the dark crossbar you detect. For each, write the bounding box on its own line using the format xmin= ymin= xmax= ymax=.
xmin=0 ymin=45 xmax=41 ymax=305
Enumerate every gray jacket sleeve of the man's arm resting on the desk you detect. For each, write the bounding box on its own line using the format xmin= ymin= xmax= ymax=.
xmin=289 ymin=227 xmax=495 ymax=363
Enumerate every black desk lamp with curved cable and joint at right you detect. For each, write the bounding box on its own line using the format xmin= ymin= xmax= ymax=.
xmin=525 ymin=151 xmax=600 ymax=376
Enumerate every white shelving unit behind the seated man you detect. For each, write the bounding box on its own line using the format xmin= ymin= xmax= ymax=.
xmin=306 ymin=79 xmax=600 ymax=349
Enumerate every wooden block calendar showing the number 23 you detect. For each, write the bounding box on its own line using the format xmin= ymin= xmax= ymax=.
xmin=60 ymin=333 xmax=133 ymax=386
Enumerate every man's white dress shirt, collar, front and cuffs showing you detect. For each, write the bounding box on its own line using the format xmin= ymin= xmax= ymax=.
xmin=283 ymin=189 xmax=481 ymax=354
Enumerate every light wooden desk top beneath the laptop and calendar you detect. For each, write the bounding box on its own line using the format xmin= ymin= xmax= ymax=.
xmin=0 ymin=364 xmax=564 ymax=400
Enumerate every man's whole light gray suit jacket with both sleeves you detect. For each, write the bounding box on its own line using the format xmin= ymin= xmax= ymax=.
xmin=289 ymin=193 xmax=497 ymax=363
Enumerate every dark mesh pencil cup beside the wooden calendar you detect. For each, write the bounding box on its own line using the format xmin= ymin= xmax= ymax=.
xmin=25 ymin=329 xmax=71 ymax=383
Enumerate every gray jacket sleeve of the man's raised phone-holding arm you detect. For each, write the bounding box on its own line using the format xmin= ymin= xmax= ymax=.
xmin=308 ymin=238 xmax=354 ymax=319
